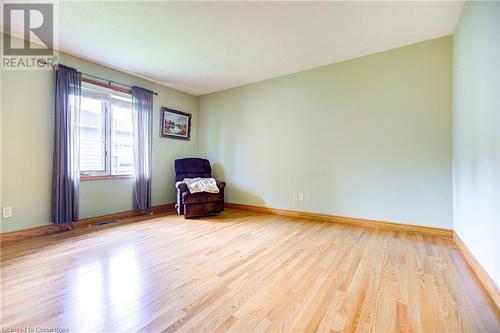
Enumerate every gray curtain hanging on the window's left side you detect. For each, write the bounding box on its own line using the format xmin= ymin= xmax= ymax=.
xmin=52 ymin=65 xmax=81 ymax=224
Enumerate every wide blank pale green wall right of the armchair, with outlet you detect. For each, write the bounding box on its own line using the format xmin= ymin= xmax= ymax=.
xmin=199 ymin=37 xmax=452 ymax=228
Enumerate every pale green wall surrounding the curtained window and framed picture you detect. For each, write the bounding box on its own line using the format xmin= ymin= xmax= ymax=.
xmin=0 ymin=45 xmax=198 ymax=232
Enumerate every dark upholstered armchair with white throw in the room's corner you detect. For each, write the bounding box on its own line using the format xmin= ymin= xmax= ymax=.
xmin=175 ymin=158 xmax=226 ymax=217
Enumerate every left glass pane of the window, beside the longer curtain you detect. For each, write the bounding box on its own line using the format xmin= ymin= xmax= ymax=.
xmin=80 ymin=96 xmax=106 ymax=174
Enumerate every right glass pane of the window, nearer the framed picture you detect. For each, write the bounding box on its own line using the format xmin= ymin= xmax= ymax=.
xmin=111 ymin=99 xmax=134 ymax=175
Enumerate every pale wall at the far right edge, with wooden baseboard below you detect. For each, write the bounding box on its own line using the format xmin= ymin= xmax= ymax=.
xmin=453 ymin=1 xmax=500 ymax=286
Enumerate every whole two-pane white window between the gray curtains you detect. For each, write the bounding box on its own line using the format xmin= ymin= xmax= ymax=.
xmin=80 ymin=82 xmax=134 ymax=176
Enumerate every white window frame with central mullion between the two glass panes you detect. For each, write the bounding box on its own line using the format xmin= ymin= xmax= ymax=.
xmin=80 ymin=78 xmax=134 ymax=181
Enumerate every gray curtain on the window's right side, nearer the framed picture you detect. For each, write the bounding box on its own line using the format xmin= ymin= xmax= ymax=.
xmin=131 ymin=87 xmax=153 ymax=211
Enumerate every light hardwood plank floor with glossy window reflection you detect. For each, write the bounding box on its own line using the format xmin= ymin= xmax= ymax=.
xmin=1 ymin=209 xmax=500 ymax=332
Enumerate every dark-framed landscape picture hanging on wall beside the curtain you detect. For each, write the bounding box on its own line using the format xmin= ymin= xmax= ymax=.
xmin=160 ymin=107 xmax=191 ymax=140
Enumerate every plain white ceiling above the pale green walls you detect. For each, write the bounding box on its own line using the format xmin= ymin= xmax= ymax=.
xmin=32 ymin=1 xmax=463 ymax=95
